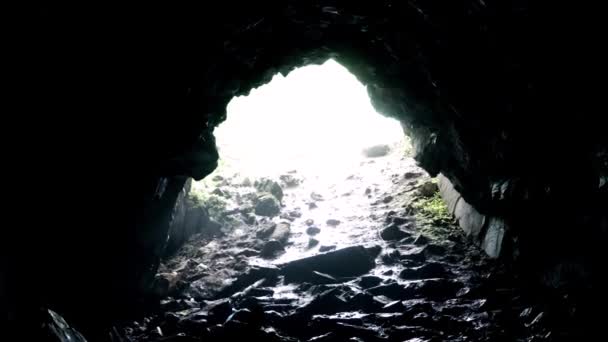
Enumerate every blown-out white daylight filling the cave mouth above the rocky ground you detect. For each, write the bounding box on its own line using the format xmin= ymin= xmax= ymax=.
xmin=203 ymin=60 xmax=404 ymax=182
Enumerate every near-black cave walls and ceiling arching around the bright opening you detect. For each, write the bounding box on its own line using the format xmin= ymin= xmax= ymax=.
xmin=5 ymin=0 xmax=608 ymax=332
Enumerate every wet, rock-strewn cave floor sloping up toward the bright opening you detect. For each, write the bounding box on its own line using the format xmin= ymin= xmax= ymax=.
xmin=120 ymin=145 xmax=552 ymax=341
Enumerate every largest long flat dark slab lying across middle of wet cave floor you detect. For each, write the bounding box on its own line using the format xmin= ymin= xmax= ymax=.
xmin=281 ymin=246 xmax=376 ymax=282
